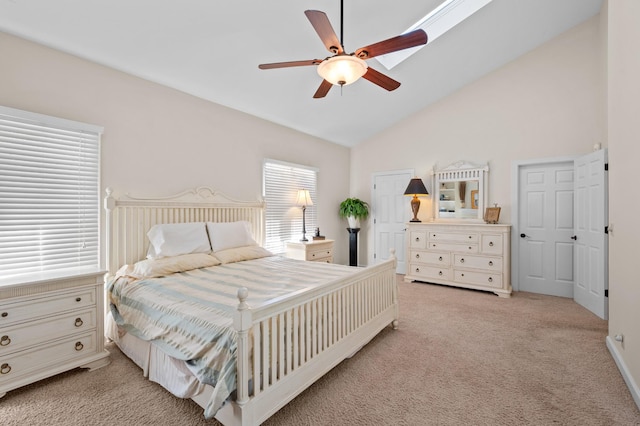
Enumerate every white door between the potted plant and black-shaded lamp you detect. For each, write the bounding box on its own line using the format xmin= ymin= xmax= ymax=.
xmin=371 ymin=170 xmax=413 ymax=274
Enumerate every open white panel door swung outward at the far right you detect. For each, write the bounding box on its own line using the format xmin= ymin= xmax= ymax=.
xmin=573 ymin=149 xmax=609 ymax=319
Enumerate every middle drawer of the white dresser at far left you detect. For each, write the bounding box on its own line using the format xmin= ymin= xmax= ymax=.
xmin=0 ymin=308 xmax=97 ymax=356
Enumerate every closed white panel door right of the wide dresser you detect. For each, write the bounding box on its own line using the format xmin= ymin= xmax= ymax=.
xmin=517 ymin=161 xmax=574 ymax=297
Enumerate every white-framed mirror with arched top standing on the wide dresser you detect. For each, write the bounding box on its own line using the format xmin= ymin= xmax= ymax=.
xmin=433 ymin=161 xmax=489 ymax=222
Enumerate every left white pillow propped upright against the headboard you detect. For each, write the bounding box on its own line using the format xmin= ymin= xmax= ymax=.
xmin=147 ymin=222 xmax=211 ymax=259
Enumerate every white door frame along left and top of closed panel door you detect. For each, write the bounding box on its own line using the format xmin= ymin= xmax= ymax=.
xmin=511 ymin=155 xmax=579 ymax=291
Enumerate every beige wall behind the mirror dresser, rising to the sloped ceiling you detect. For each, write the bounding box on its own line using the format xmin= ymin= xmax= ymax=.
xmin=351 ymin=17 xmax=606 ymax=264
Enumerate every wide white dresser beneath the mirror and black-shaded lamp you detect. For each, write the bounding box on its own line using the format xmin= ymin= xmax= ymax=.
xmin=404 ymin=222 xmax=511 ymax=297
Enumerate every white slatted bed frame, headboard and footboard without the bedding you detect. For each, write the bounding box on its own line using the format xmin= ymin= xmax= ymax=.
xmin=104 ymin=187 xmax=398 ymax=425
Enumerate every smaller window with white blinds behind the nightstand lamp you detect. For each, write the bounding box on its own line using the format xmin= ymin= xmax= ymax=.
xmin=263 ymin=160 xmax=318 ymax=253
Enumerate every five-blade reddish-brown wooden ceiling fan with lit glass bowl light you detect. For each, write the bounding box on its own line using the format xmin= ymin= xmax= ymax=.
xmin=258 ymin=1 xmax=427 ymax=98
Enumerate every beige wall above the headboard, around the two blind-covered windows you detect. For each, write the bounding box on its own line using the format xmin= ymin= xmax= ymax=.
xmin=0 ymin=33 xmax=350 ymax=264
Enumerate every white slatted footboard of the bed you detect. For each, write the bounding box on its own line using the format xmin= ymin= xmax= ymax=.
xmin=221 ymin=252 xmax=398 ymax=425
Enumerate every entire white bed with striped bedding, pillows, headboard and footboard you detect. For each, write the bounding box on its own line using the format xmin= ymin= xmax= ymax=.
xmin=104 ymin=187 xmax=398 ymax=425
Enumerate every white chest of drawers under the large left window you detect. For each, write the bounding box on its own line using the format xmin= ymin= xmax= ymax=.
xmin=0 ymin=272 xmax=110 ymax=397
